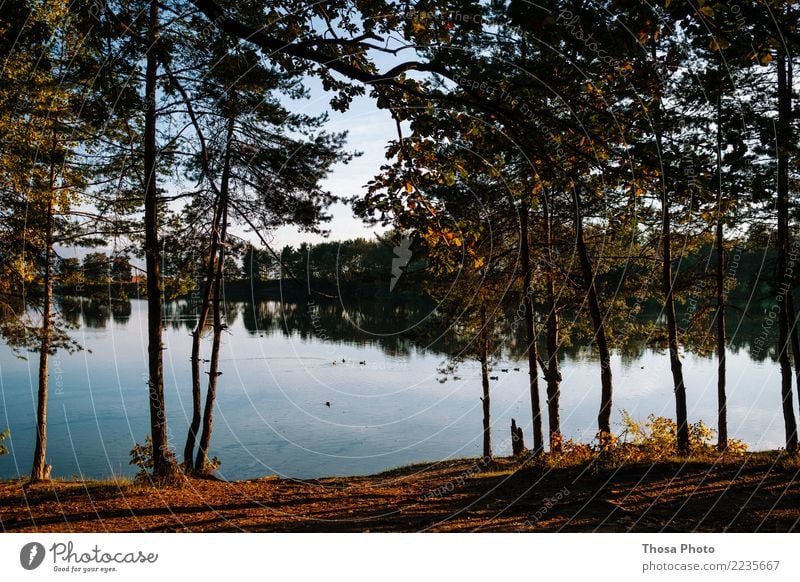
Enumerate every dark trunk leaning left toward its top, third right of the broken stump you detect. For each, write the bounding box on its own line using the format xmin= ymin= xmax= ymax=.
xmin=572 ymin=187 xmax=614 ymax=447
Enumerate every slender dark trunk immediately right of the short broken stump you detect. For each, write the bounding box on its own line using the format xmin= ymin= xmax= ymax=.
xmin=520 ymin=205 xmax=544 ymax=455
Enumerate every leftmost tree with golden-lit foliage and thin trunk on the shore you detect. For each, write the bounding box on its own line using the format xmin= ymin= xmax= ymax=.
xmin=0 ymin=2 xmax=104 ymax=482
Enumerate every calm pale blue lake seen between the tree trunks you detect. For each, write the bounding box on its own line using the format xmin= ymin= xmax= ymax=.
xmin=0 ymin=299 xmax=784 ymax=479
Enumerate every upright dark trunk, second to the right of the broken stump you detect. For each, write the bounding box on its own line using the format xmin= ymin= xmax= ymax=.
xmin=542 ymin=194 xmax=561 ymax=453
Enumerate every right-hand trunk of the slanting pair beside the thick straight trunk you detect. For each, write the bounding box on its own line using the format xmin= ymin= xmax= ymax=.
xmin=194 ymin=118 xmax=234 ymax=474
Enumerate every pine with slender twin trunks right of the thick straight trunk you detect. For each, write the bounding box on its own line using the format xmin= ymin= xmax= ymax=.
xmin=165 ymin=9 xmax=352 ymax=473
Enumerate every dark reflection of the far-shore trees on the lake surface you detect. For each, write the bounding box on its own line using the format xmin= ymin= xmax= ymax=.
xmin=57 ymin=293 xmax=776 ymax=366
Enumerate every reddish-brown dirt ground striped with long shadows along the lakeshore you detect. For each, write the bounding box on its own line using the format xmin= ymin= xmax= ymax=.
xmin=0 ymin=453 xmax=800 ymax=532
